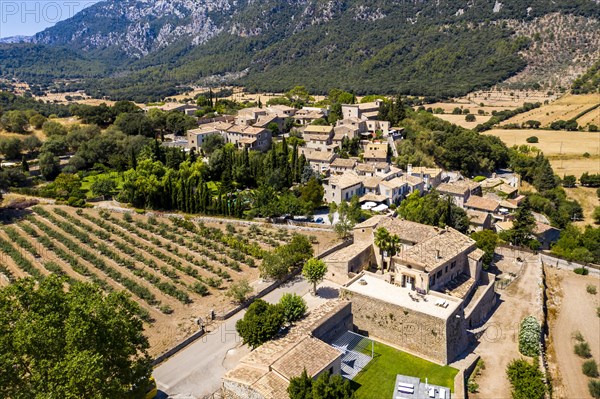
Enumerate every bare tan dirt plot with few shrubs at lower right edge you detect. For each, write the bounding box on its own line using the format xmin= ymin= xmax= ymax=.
xmin=546 ymin=267 xmax=600 ymax=398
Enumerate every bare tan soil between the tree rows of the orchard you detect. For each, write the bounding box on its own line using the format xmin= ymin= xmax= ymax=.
xmin=0 ymin=206 xmax=338 ymax=355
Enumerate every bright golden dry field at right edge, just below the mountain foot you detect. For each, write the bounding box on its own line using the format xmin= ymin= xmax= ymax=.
xmin=502 ymin=94 xmax=600 ymax=127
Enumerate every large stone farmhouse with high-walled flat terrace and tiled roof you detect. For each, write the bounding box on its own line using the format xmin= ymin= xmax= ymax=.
xmin=324 ymin=216 xmax=496 ymax=364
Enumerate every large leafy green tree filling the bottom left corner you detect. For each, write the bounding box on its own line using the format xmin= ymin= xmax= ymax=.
xmin=0 ymin=275 xmax=152 ymax=399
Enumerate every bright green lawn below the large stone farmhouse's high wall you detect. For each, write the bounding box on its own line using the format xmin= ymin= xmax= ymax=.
xmin=353 ymin=342 xmax=458 ymax=399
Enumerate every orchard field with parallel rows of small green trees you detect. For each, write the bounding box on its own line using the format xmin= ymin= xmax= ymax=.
xmin=0 ymin=206 xmax=337 ymax=355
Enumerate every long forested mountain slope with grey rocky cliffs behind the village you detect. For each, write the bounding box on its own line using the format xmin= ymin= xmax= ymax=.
xmin=0 ymin=0 xmax=600 ymax=100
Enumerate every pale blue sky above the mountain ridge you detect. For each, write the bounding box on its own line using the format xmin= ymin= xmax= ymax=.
xmin=0 ymin=0 xmax=99 ymax=38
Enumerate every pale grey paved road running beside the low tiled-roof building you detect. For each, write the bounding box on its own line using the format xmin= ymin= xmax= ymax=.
xmin=153 ymin=277 xmax=310 ymax=399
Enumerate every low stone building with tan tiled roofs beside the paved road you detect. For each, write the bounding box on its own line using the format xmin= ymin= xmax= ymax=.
xmin=222 ymin=300 xmax=352 ymax=399
